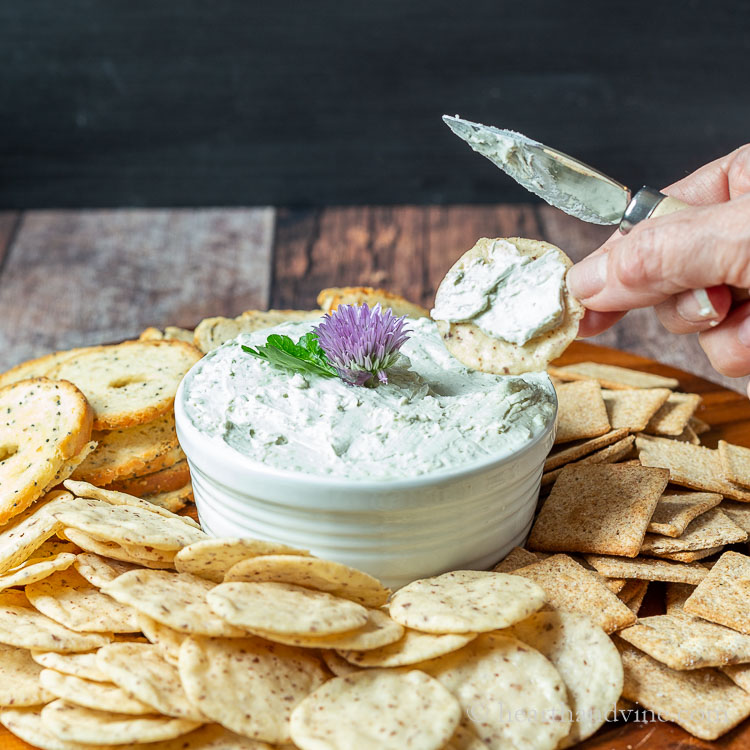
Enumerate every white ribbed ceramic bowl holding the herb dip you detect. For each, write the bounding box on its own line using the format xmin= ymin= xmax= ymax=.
xmin=175 ymin=375 xmax=555 ymax=588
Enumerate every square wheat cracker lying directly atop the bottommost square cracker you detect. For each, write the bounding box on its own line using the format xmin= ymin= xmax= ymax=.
xmin=618 ymin=614 xmax=750 ymax=669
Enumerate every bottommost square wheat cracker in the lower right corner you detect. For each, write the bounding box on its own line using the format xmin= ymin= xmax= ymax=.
xmin=617 ymin=640 xmax=750 ymax=740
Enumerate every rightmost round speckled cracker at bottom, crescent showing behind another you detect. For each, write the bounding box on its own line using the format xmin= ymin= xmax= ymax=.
xmin=510 ymin=612 xmax=623 ymax=748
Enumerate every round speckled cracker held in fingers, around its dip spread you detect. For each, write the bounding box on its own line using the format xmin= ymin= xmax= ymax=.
xmin=437 ymin=237 xmax=585 ymax=375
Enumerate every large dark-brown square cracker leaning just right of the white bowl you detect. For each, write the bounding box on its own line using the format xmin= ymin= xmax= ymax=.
xmin=527 ymin=464 xmax=669 ymax=560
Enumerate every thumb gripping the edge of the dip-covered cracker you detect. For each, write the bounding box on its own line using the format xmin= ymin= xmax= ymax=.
xmin=567 ymin=194 xmax=750 ymax=312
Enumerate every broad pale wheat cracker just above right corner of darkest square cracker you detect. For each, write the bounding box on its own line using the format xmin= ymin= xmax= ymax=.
xmin=635 ymin=435 xmax=750 ymax=502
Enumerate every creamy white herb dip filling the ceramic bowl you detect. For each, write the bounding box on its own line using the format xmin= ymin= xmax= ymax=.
xmin=184 ymin=318 xmax=555 ymax=480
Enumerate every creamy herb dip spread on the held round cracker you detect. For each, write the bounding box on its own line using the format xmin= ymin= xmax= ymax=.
xmin=430 ymin=240 xmax=567 ymax=345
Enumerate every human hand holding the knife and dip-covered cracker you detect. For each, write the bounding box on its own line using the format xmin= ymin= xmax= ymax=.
xmin=568 ymin=144 xmax=750 ymax=377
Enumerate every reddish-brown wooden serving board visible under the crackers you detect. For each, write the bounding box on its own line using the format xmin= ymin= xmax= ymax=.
xmin=0 ymin=341 xmax=750 ymax=750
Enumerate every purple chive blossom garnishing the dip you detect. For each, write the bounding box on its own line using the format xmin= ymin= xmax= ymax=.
xmin=315 ymin=303 xmax=410 ymax=385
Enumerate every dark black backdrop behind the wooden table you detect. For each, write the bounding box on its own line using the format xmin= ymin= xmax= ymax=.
xmin=0 ymin=0 xmax=750 ymax=208
